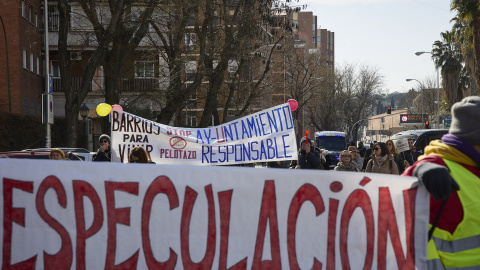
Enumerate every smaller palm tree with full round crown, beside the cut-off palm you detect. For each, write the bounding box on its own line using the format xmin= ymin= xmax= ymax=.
xmin=432 ymin=31 xmax=463 ymax=105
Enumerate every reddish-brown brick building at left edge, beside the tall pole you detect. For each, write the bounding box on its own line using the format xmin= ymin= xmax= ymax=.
xmin=0 ymin=0 xmax=45 ymax=115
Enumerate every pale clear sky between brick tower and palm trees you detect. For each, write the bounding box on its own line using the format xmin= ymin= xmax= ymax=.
xmin=296 ymin=0 xmax=456 ymax=93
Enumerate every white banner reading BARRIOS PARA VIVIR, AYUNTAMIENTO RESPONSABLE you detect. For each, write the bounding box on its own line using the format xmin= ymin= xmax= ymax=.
xmin=111 ymin=103 xmax=298 ymax=165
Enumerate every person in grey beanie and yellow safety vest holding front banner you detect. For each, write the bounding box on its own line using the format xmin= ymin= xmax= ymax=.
xmin=402 ymin=96 xmax=480 ymax=269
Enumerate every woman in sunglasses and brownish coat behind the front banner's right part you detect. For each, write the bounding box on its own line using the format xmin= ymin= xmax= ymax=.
xmin=365 ymin=142 xmax=398 ymax=175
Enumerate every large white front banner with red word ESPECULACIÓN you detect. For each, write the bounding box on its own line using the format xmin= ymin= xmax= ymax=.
xmin=0 ymin=159 xmax=429 ymax=269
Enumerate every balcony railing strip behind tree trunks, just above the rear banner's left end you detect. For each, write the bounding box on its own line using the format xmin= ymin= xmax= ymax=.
xmin=53 ymin=77 xmax=159 ymax=93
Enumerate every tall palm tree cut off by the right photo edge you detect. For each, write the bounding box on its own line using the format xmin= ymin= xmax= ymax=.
xmin=451 ymin=0 xmax=480 ymax=88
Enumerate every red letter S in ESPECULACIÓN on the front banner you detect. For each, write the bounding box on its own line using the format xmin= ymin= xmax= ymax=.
xmin=35 ymin=176 xmax=73 ymax=269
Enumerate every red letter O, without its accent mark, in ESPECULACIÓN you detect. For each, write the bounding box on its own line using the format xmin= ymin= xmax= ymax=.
xmin=340 ymin=189 xmax=375 ymax=269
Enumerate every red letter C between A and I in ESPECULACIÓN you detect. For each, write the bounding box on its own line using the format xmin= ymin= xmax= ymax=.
xmin=287 ymin=184 xmax=325 ymax=269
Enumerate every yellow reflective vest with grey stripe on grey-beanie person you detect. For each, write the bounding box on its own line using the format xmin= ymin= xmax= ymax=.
xmin=427 ymin=159 xmax=480 ymax=269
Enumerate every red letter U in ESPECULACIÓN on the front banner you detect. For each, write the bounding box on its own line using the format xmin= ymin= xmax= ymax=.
xmin=180 ymin=185 xmax=217 ymax=269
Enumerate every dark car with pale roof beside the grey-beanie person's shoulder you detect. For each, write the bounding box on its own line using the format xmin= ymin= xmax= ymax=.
xmin=391 ymin=129 xmax=448 ymax=155
